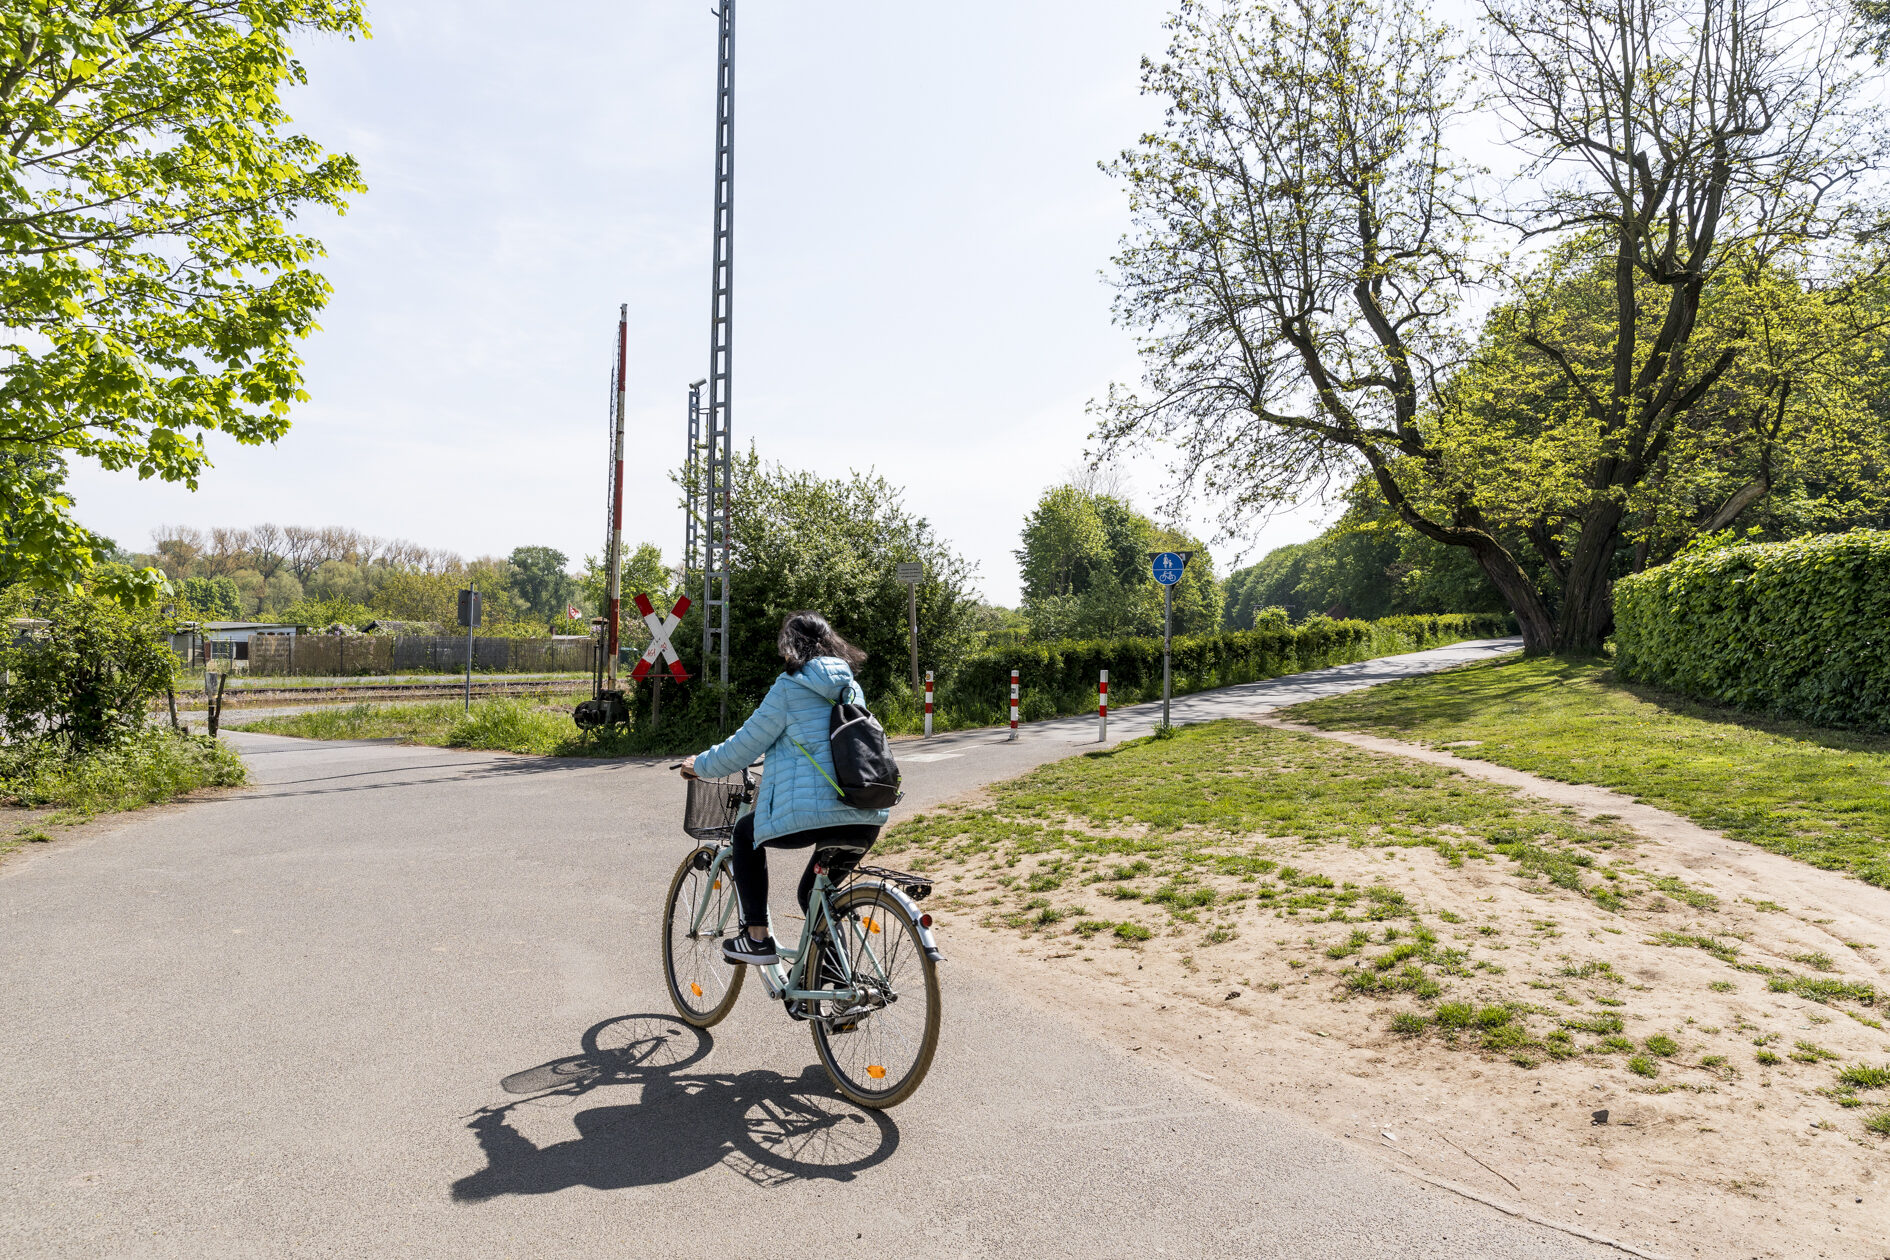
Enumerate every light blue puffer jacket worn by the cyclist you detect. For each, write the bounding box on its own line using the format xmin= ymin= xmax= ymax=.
xmin=696 ymin=656 xmax=890 ymax=841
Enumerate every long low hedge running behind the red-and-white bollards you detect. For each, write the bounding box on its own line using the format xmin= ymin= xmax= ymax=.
xmin=939 ymin=612 xmax=1516 ymax=725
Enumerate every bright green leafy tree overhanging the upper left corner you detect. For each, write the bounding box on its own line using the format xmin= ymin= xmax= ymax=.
xmin=0 ymin=0 xmax=365 ymax=593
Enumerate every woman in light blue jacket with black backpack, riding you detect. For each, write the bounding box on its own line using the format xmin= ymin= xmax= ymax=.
xmin=682 ymin=612 xmax=888 ymax=963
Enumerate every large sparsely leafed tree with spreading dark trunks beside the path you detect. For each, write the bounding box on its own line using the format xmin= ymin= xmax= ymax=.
xmin=1100 ymin=0 xmax=1882 ymax=652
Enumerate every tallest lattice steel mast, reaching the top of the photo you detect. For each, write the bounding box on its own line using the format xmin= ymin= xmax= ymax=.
xmin=703 ymin=0 xmax=735 ymax=729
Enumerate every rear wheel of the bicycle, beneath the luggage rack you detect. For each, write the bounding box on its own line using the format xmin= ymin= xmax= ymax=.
xmin=809 ymin=884 xmax=939 ymax=1109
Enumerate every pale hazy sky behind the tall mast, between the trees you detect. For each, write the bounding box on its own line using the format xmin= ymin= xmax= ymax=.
xmin=72 ymin=0 xmax=1317 ymax=603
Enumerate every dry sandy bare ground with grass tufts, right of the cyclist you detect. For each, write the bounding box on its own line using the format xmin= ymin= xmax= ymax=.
xmin=922 ymin=727 xmax=1890 ymax=1260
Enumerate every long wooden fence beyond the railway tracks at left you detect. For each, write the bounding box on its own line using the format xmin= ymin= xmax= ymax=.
xmin=249 ymin=635 xmax=597 ymax=676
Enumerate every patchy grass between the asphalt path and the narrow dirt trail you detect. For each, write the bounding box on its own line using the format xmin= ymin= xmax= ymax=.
xmin=875 ymin=722 xmax=1663 ymax=944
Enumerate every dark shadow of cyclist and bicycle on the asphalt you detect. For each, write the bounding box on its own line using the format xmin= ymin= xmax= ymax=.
xmin=454 ymin=1014 xmax=900 ymax=1203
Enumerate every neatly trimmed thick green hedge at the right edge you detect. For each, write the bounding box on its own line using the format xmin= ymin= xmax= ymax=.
xmin=1614 ymin=529 xmax=1890 ymax=729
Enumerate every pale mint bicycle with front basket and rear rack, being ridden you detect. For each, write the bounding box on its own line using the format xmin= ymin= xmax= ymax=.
xmin=663 ymin=771 xmax=943 ymax=1109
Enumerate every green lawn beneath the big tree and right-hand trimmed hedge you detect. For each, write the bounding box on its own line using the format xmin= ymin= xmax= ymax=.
xmin=1280 ymin=657 xmax=1890 ymax=888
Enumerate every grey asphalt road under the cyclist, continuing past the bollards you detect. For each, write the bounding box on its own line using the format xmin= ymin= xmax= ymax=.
xmin=0 ymin=644 xmax=1608 ymax=1260
